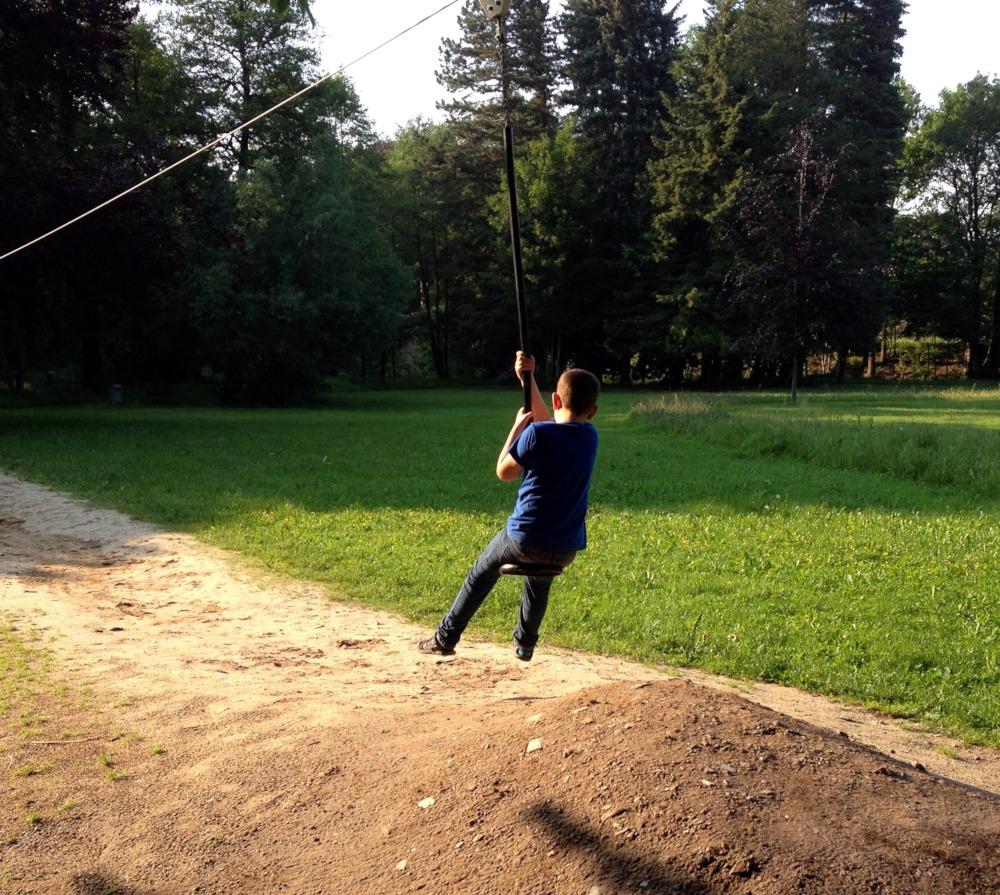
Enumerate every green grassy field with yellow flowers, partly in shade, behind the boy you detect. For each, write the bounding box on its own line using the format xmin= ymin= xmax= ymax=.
xmin=0 ymin=386 xmax=1000 ymax=746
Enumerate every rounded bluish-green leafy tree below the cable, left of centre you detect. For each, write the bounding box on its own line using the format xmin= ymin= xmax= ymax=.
xmin=194 ymin=134 xmax=409 ymax=404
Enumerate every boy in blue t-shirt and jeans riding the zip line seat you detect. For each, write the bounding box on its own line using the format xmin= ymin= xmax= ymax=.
xmin=419 ymin=351 xmax=601 ymax=662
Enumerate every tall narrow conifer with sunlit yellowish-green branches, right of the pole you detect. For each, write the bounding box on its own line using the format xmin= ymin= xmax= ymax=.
xmin=649 ymin=0 xmax=753 ymax=385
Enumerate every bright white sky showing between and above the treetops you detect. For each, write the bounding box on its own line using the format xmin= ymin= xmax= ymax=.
xmin=312 ymin=0 xmax=1000 ymax=136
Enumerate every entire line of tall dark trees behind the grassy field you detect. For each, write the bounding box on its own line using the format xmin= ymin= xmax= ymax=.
xmin=0 ymin=0 xmax=1000 ymax=404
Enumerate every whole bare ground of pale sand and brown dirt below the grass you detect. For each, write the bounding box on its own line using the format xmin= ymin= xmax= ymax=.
xmin=0 ymin=476 xmax=1000 ymax=895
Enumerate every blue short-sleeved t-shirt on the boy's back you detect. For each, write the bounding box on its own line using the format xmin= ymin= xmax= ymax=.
xmin=507 ymin=422 xmax=597 ymax=551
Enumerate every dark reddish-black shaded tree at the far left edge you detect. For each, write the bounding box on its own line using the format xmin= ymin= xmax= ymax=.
xmin=0 ymin=0 xmax=136 ymax=390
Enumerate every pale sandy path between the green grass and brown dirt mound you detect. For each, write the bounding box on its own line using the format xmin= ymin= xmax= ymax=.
xmin=0 ymin=475 xmax=1000 ymax=793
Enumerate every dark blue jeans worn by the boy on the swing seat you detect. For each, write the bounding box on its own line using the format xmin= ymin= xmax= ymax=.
xmin=437 ymin=526 xmax=576 ymax=649
